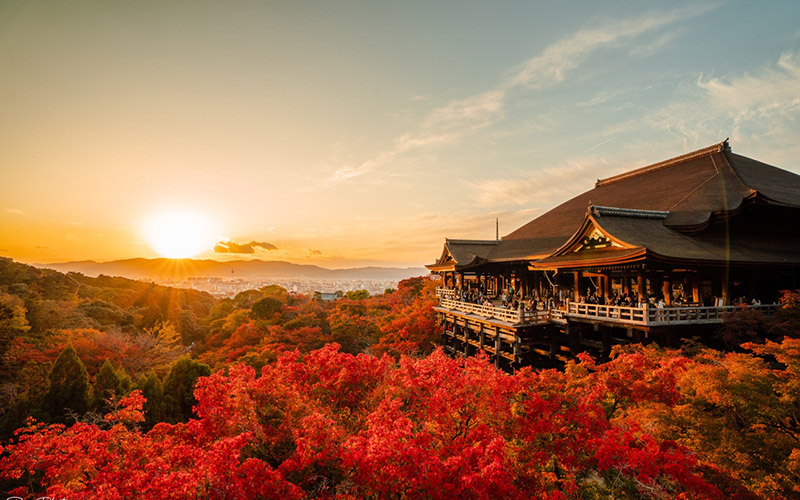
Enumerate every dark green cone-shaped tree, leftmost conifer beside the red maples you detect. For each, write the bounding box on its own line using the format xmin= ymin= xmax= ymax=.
xmin=44 ymin=344 xmax=89 ymax=423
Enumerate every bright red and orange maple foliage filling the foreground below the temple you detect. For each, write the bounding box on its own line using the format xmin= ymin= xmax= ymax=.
xmin=0 ymin=340 xmax=800 ymax=498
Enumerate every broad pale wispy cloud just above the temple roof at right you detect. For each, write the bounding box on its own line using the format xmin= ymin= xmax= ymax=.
xmin=472 ymin=47 xmax=800 ymax=207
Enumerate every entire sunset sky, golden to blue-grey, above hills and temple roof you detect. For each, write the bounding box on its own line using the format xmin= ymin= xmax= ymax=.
xmin=0 ymin=0 xmax=800 ymax=267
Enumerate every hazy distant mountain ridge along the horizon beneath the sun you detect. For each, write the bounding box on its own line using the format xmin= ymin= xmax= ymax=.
xmin=35 ymin=259 xmax=428 ymax=280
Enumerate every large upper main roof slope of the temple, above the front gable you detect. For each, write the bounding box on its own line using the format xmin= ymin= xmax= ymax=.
xmin=490 ymin=140 xmax=800 ymax=260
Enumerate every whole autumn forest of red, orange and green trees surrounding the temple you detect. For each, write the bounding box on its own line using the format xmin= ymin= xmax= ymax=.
xmin=0 ymin=259 xmax=800 ymax=498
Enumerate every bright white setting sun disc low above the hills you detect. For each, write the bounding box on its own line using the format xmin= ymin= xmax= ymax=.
xmin=142 ymin=212 xmax=217 ymax=259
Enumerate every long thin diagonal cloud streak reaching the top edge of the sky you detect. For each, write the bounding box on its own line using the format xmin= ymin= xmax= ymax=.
xmin=322 ymin=5 xmax=717 ymax=186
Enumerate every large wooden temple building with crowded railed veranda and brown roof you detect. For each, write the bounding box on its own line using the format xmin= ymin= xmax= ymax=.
xmin=427 ymin=140 xmax=800 ymax=369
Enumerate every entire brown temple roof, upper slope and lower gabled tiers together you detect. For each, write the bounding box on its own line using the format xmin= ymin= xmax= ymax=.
xmin=427 ymin=140 xmax=800 ymax=271
